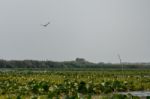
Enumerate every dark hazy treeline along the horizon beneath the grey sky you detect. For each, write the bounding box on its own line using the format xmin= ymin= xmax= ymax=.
xmin=0 ymin=58 xmax=150 ymax=69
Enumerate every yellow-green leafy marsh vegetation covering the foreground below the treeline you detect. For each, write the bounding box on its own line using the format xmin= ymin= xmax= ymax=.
xmin=0 ymin=70 xmax=150 ymax=99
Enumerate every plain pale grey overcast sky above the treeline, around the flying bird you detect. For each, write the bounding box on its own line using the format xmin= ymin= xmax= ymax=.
xmin=0 ymin=0 xmax=150 ymax=62
